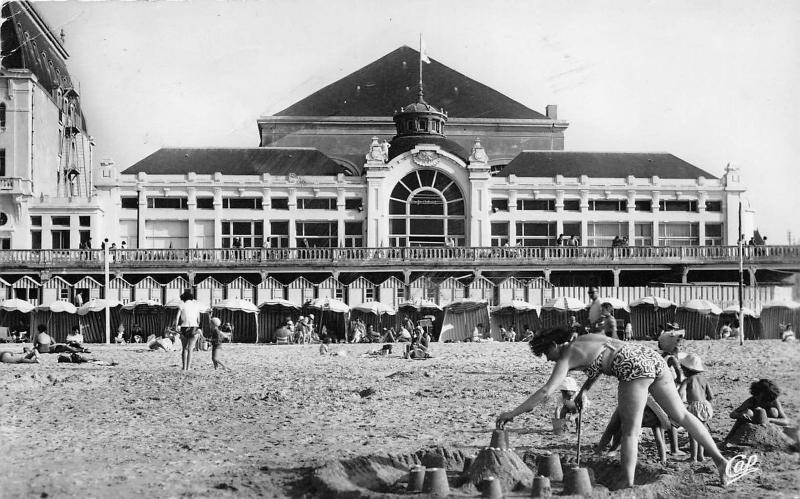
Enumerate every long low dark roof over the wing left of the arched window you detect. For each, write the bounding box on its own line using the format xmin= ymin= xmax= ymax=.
xmin=122 ymin=147 xmax=346 ymax=175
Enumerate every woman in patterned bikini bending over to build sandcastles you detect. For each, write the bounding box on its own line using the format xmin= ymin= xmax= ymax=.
xmin=497 ymin=328 xmax=728 ymax=487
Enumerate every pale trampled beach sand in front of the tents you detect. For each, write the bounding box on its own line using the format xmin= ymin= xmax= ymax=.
xmin=0 ymin=341 xmax=800 ymax=498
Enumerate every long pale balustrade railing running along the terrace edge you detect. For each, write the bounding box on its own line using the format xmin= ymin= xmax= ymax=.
xmin=0 ymin=245 xmax=800 ymax=269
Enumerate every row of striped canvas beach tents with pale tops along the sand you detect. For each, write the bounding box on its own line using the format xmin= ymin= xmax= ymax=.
xmin=0 ymin=296 xmax=800 ymax=343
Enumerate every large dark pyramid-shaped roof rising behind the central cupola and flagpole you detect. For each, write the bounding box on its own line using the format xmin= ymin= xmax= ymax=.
xmin=276 ymin=46 xmax=544 ymax=119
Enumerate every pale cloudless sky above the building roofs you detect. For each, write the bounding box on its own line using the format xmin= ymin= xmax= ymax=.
xmin=36 ymin=0 xmax=800 ymax=244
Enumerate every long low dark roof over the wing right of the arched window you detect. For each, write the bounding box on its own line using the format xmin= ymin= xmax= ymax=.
xmin=497 ymin=151 xmax=716 ymax=179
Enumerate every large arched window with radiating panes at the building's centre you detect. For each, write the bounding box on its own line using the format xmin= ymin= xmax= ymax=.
xmin=389 ymin=170 xmax=466 ymax=247
